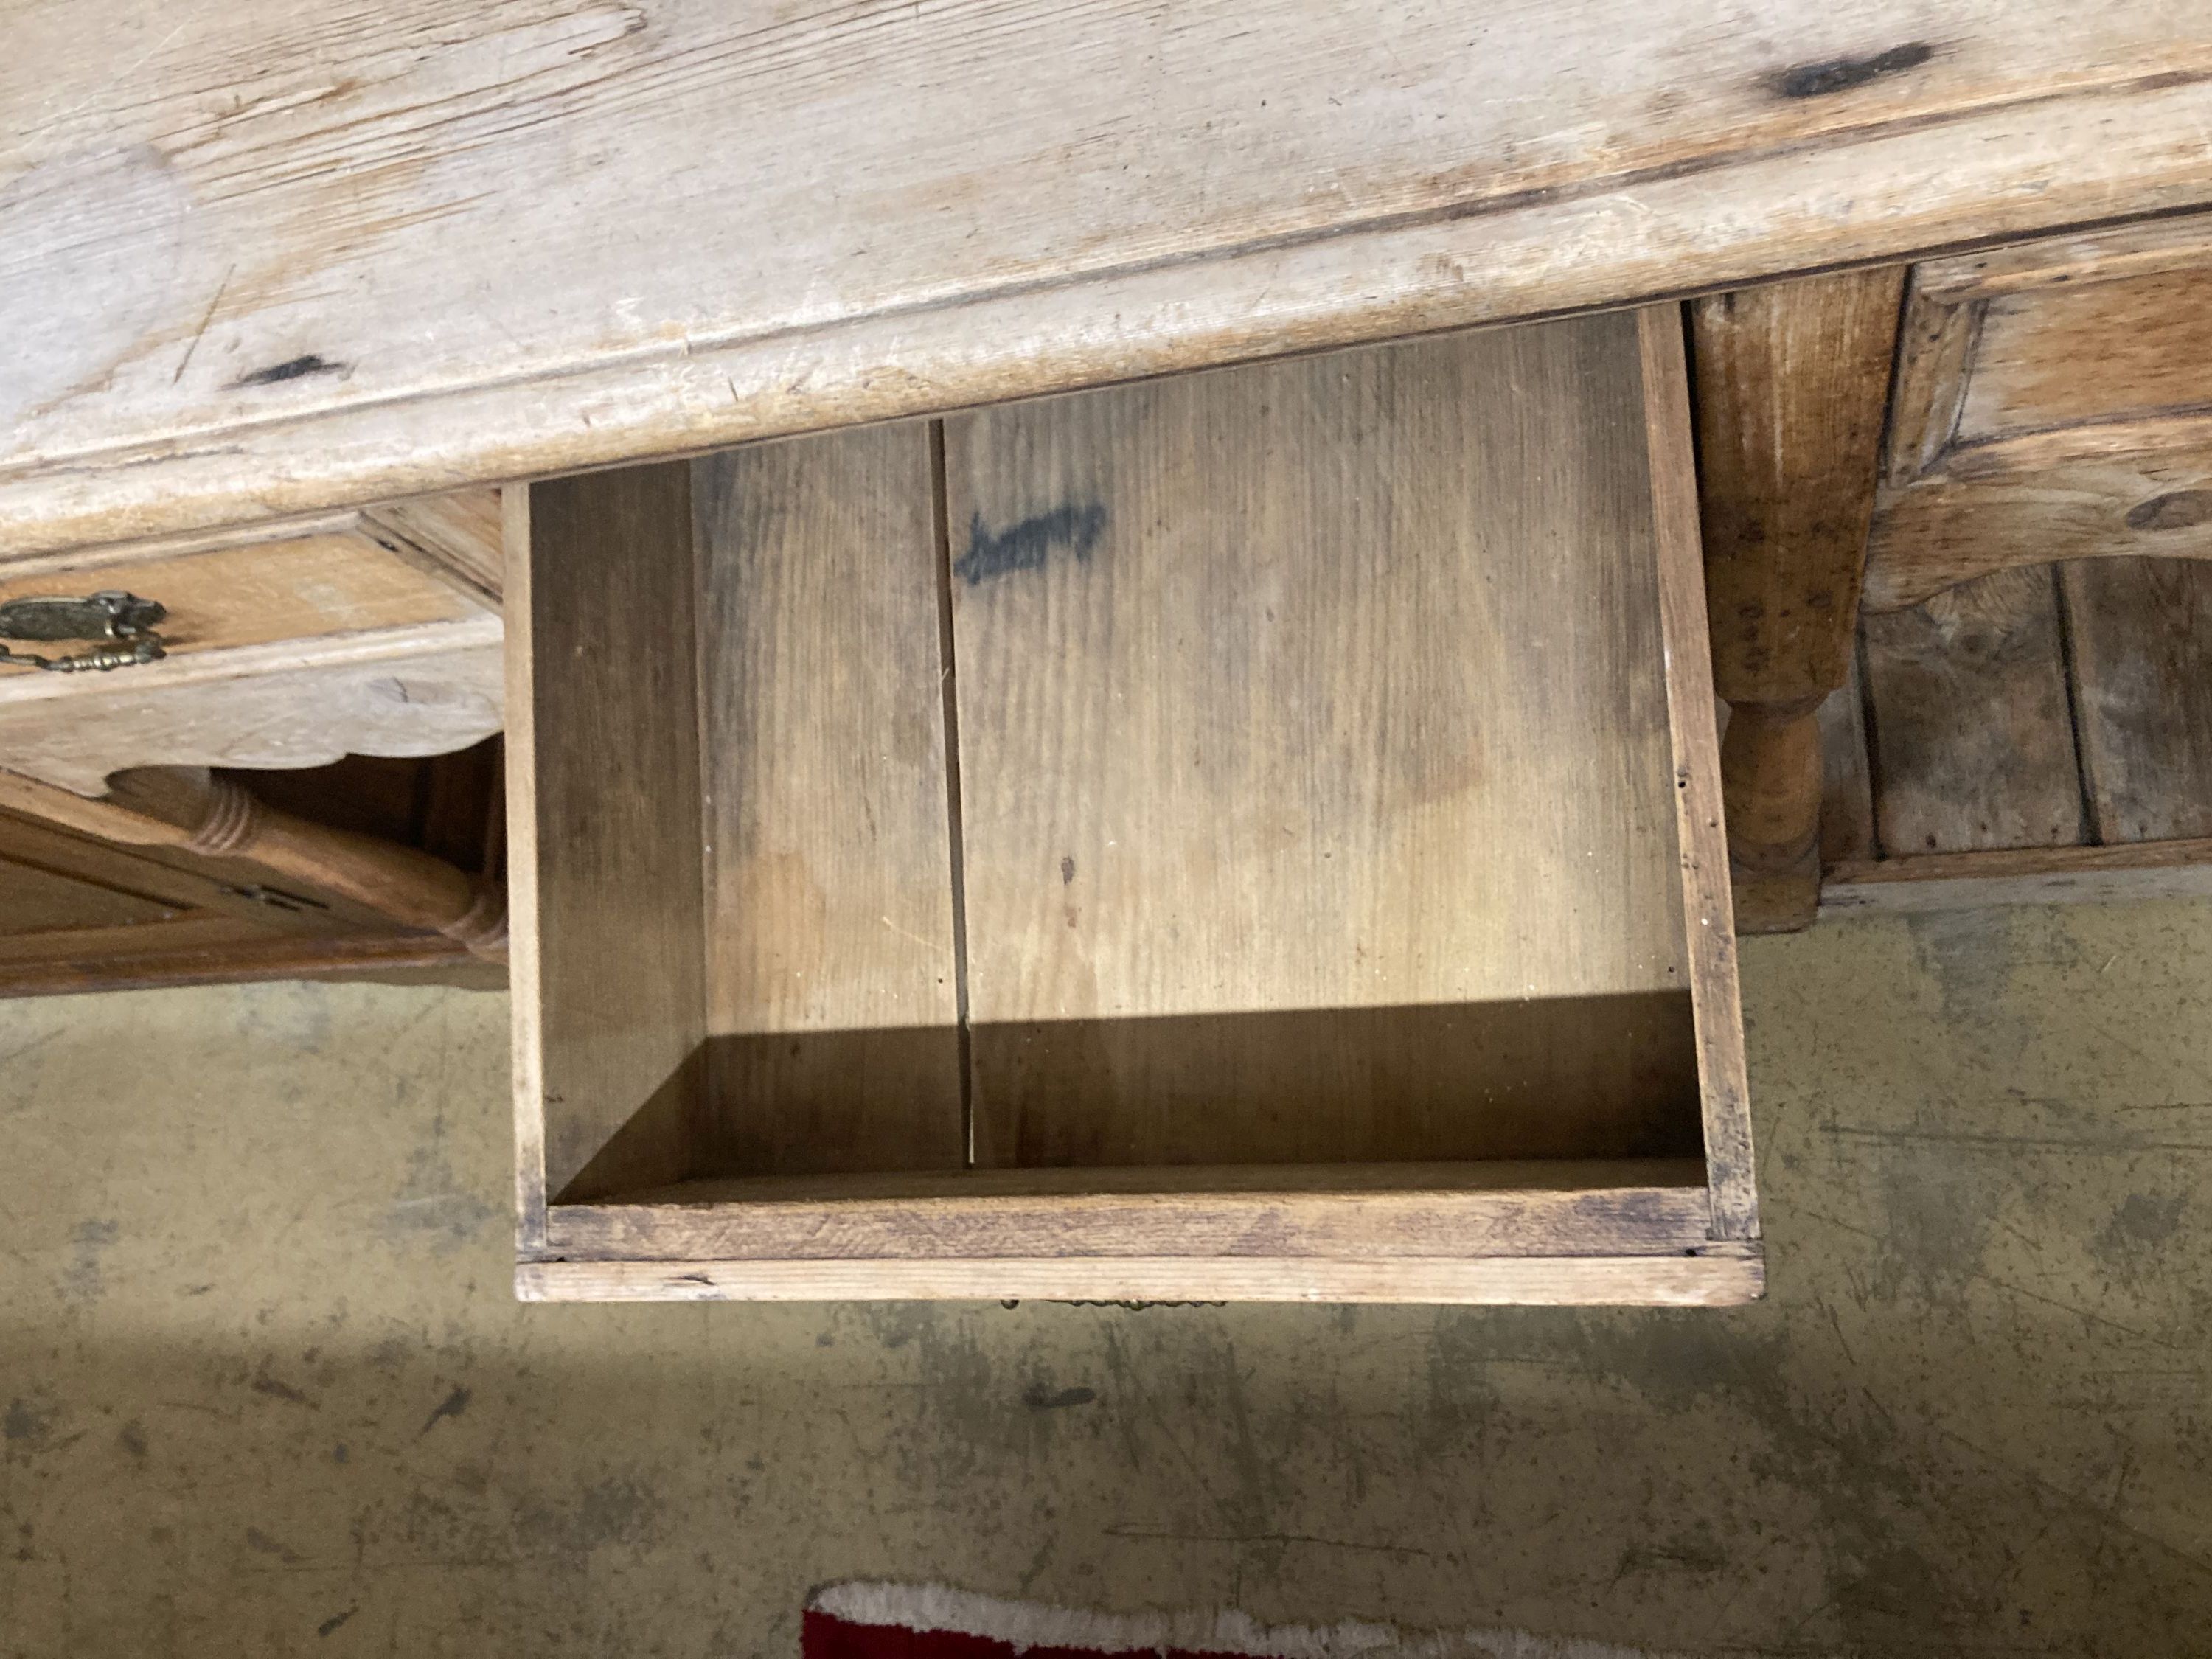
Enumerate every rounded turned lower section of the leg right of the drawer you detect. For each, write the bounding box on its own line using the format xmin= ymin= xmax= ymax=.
xmin=1721 ymin=697 xmax=1820 ymax=933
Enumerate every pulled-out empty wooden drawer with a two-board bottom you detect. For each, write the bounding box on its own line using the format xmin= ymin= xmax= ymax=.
xmin=507 ymin=307 xmax=1761 ymax=1303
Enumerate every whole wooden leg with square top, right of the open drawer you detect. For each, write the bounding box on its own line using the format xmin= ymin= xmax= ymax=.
xmin=1690 ymin=268 xmax=1905 ymax=933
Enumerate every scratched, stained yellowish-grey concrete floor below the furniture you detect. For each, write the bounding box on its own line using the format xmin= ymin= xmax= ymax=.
xmin=0 ymin=905 xmax=2212 ymax=1659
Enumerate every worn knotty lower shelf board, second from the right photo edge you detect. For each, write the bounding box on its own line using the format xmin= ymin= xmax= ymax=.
xmin=1865 ymin=568 xmax=2086 ymax=856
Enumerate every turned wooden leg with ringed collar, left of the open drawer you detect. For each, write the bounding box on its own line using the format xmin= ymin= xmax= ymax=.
xmin=0 ymin=765 xmax=507 ymax=960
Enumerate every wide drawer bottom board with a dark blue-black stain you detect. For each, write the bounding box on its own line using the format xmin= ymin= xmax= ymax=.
xmin=947 ymin=316 xmax=1710 ymax=1166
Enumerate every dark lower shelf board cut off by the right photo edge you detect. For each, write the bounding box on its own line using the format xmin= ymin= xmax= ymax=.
xmin=2059 ymin=560 xmax=2212 ymax=843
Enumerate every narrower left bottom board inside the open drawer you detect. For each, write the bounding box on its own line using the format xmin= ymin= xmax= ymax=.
xmin=695 ymin=422 xmax=967 ymax=1172
